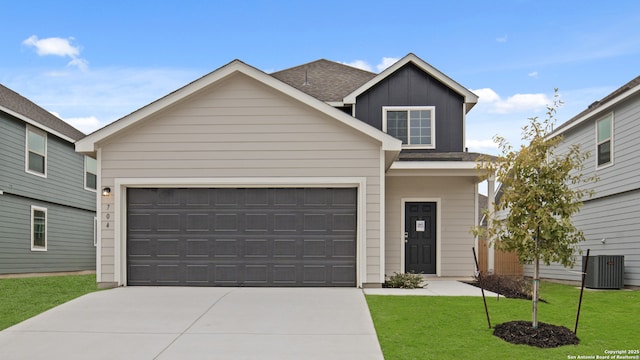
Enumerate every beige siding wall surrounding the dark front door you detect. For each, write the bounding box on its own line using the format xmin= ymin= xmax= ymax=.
xmin=385 ymin=176 xmax=476 ymax=276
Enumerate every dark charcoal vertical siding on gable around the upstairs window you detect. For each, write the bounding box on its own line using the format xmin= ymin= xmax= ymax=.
xmin=356 ymin=64 xmax=464 ymax=152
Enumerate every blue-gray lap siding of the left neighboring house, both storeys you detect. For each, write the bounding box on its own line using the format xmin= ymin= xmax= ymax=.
xmin=0 ymin=113 xmax=96 ymax=273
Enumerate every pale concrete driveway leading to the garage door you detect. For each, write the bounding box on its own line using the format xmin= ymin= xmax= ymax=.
xmin=0 ymin=287 xmax=383 ymax=360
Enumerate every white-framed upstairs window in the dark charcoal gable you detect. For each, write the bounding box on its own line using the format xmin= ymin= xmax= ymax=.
xmin=382 ymin=106 xmax=436 ymax=149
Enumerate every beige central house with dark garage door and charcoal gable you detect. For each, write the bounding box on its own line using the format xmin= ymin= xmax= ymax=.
xmin=76 ymin=54 xmax=496 ymax=287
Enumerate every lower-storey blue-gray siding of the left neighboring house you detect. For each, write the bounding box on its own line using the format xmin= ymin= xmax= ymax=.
xmin=0 ymin=193 xmax=96 ymax=274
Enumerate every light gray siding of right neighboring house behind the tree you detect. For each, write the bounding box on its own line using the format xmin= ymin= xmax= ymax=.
xmin=525 ymin=91 xmax=640 ymax=286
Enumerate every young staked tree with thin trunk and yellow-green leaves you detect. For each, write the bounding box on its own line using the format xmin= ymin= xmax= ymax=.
xmin=473 ymin=89 xmax=595 ymax=328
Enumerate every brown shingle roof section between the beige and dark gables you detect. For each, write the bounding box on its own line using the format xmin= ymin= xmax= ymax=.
xmin=271 ymin=59 xmax=376 ymax=102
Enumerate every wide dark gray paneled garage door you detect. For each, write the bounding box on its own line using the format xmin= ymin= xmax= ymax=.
xmin=127 ymin=188 xmax=357 ymax=286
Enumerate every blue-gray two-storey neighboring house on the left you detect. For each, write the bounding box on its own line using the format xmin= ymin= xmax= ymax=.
xmin=0 ymin=85 xmax=97 ymax=274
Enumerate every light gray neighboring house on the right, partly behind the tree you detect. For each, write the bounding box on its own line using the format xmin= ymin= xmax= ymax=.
xmin=525 ymin=76 xmax=640 ymax=286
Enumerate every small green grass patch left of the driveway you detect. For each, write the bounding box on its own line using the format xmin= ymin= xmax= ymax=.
xmin=0 ymin=275 xmax=98 ymax=330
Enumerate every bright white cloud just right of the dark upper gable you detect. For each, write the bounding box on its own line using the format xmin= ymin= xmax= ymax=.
xmin=473 ymin=88 xmax=551 ymax=114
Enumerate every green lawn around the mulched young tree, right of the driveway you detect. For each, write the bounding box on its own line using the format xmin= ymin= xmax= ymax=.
xmin=367 ymin=282 xmax=640 ymax=360
